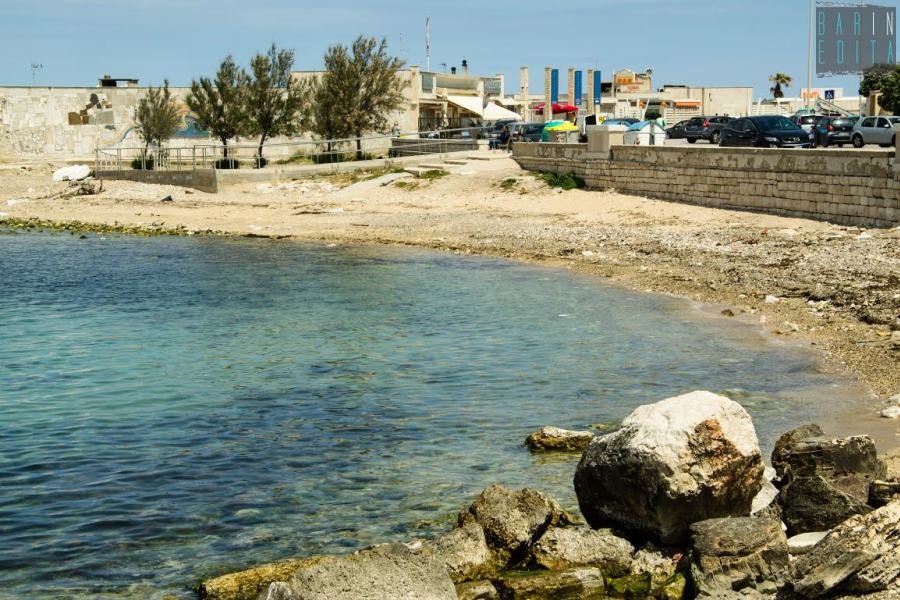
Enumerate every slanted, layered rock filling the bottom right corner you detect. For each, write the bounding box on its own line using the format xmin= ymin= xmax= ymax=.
xmin=794 ymin=501 xmax=900 ymax=598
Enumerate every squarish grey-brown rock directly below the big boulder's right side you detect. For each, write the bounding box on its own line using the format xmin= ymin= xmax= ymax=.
xmin=691 ymin=517 xmax=790 ymax=597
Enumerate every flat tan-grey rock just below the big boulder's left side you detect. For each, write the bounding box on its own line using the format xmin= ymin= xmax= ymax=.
xmin=529 ymin=527 xmax=634 ymax=577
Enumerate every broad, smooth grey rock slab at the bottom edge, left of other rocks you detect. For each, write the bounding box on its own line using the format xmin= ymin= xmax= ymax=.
xmin=260 ymin=544 xmax=457 ymax=600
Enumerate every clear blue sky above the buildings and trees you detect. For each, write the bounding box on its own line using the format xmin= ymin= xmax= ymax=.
xmin=0 ymin=0 xmax=895 ymax=98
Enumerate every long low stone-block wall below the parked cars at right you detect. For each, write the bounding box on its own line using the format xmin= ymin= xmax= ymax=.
xmin=513 ymin=143 xmax=900 ymax=227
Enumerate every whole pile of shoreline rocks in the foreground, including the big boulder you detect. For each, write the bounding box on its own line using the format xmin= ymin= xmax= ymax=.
xmin=198 ymin=392 xmax=900 ymax=600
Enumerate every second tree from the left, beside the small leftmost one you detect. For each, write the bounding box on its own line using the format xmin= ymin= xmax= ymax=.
xmin=186 ymin=56 xmax=247 ymax=158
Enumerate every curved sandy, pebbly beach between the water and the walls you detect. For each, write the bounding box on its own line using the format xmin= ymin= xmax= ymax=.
xmin=0 ymin=154 xmax=900 ymax=447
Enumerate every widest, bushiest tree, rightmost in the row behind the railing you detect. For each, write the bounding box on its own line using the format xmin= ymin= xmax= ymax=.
xmin=313 ymin=36 xmax=408 ymax=160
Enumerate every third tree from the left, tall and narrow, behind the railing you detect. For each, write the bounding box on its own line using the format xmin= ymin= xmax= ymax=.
xmin=243 ymin=44 xmax=305 ymax=166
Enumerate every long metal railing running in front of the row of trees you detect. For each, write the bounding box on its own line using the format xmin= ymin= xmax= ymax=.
xmin=95 ymin=127 xmax=490 ymax=171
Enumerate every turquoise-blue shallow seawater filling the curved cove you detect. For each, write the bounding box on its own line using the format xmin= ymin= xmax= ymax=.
xmin=0 ymin=233 xmax=856 ymax=598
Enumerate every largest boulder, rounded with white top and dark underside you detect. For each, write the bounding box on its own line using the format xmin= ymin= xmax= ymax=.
xmin=575 ymin=392 xmax=763 ymax=544
